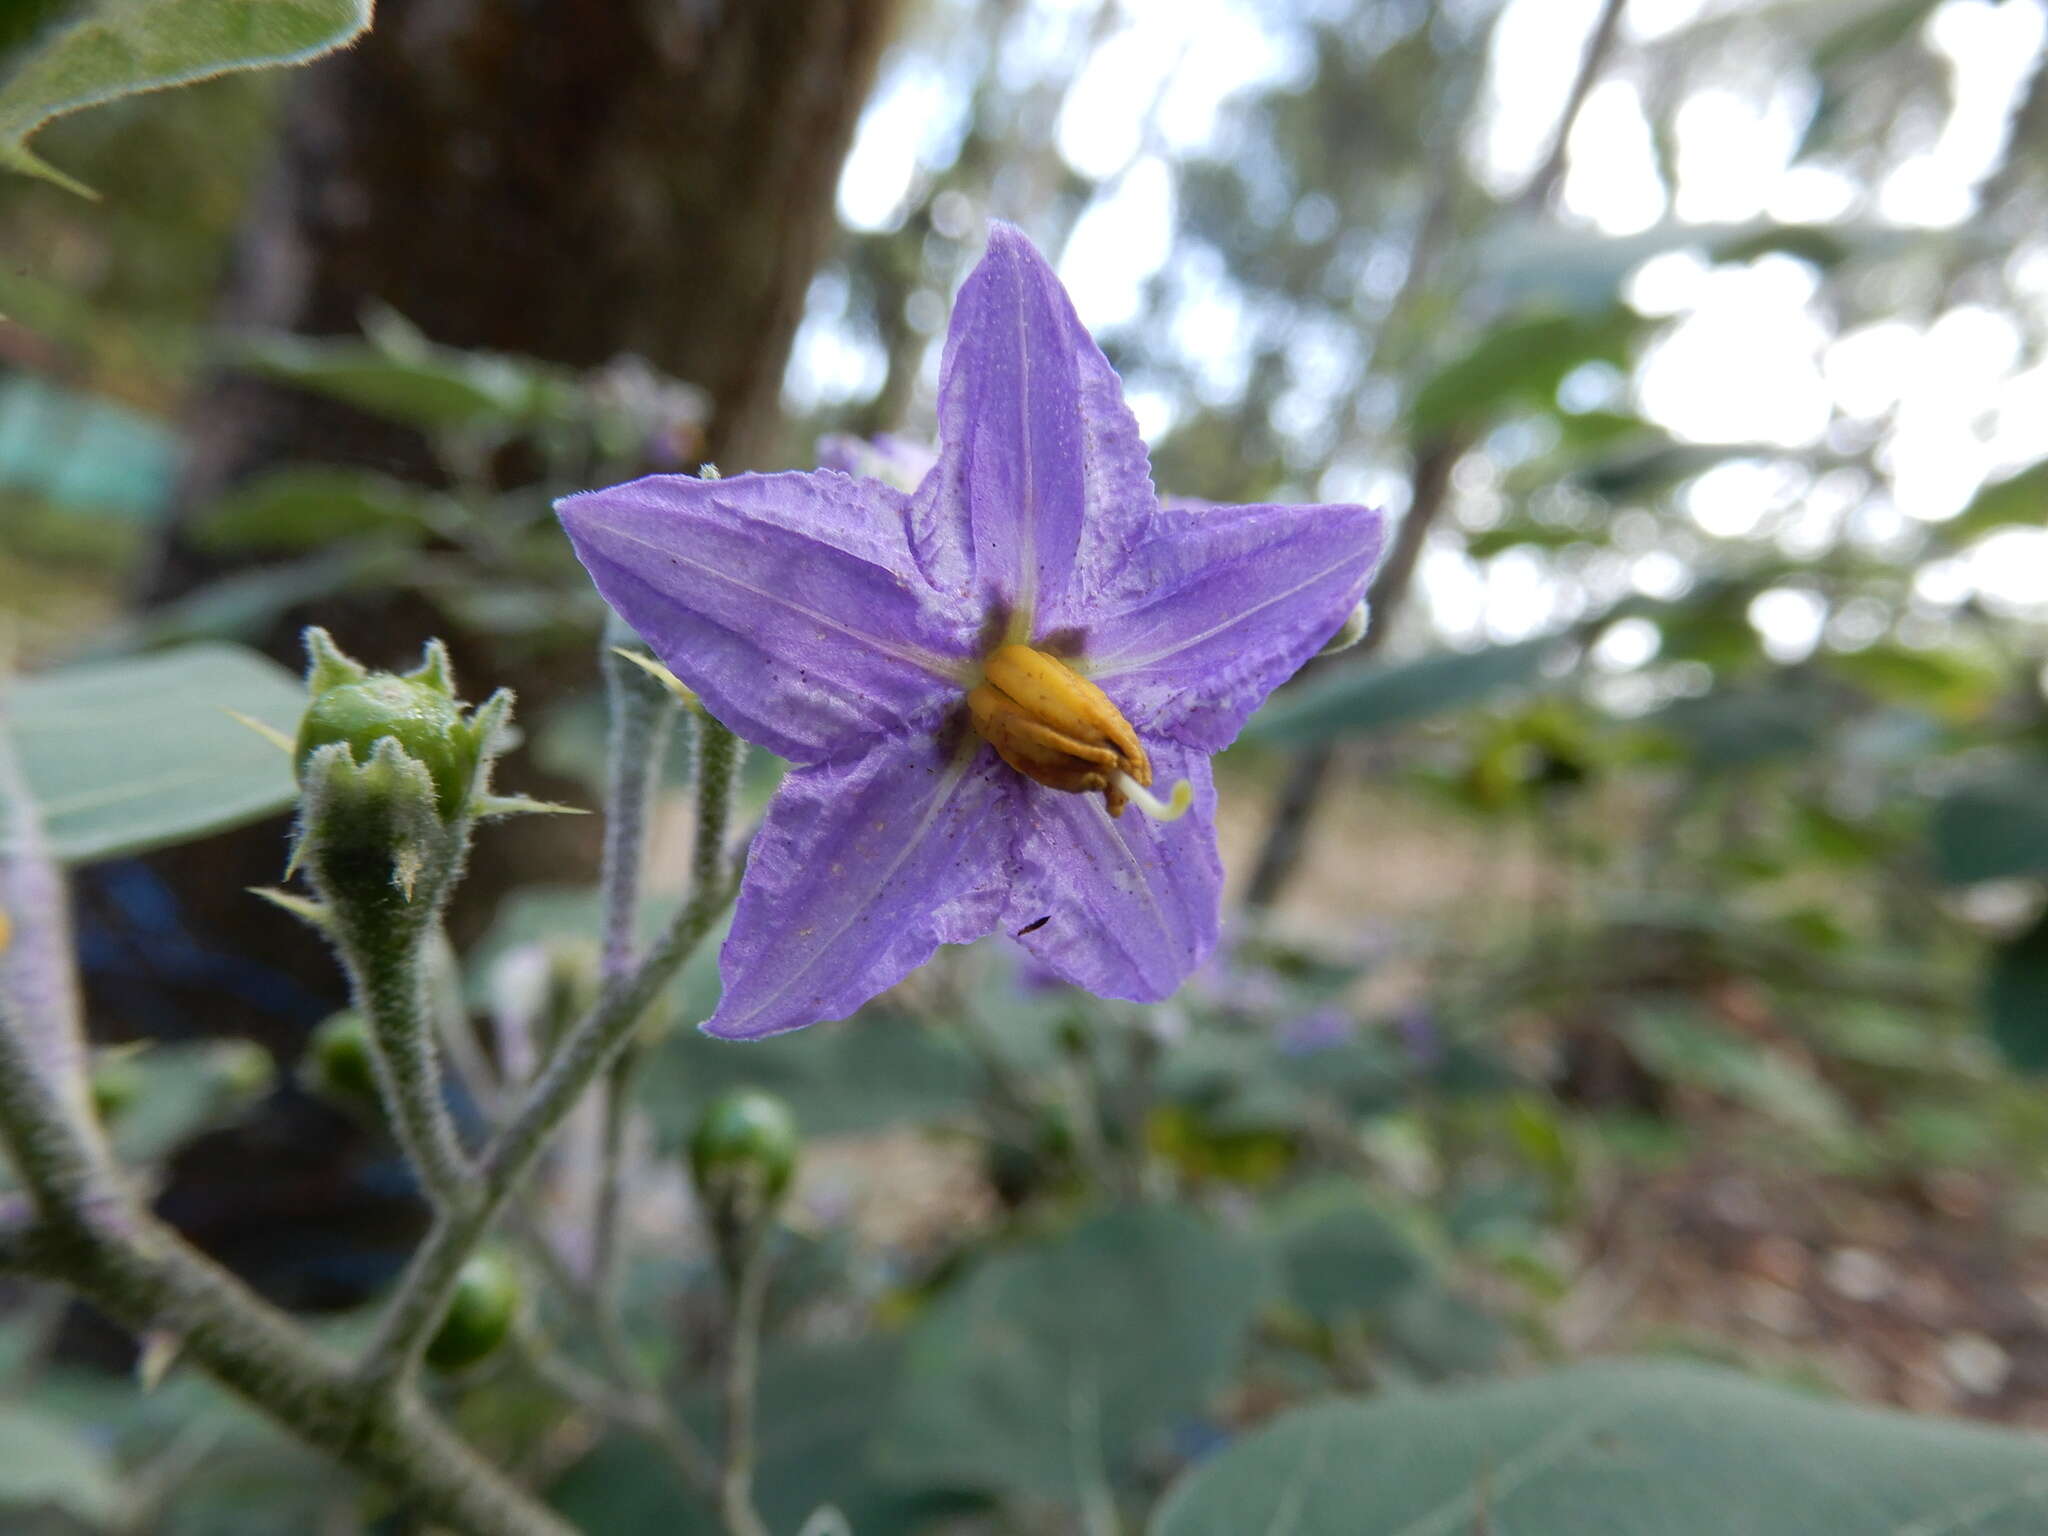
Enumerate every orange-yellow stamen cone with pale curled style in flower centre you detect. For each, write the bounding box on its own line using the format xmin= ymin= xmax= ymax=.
xmin=967 ymin=645 xmax=1194 ymax=821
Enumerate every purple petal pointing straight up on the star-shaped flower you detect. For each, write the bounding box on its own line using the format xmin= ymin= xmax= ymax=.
xmin=911 ymin=223 xmax=1157 ymax=639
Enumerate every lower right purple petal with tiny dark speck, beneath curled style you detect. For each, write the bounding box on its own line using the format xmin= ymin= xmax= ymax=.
xmin=1004 ymin=741 xmax=1223 ymax=1004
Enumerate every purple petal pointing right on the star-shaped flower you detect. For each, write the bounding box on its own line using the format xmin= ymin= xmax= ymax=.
xmin=1083 ymin=506 xmax=1386 ymax=752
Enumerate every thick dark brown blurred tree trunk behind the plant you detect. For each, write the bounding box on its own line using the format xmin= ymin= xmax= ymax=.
xmin=121 ymin=0 xmax=895 ymax=1057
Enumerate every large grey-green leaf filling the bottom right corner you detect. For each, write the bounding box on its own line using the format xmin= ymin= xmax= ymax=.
xmin=1149 ymin=1362 xmax=2048 ymax=1536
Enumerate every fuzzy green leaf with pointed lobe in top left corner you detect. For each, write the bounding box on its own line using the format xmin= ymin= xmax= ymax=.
xmin=0 ymin=0 xmax=373 ymax=197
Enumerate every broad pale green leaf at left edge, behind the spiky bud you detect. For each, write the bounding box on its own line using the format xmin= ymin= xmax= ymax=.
xmin=10 ymin=645 xmax=305 ymax=868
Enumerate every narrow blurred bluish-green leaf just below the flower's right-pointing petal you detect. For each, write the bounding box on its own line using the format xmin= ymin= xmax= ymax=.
xmin=1245 ymin=635 xmax=1559 ymax=743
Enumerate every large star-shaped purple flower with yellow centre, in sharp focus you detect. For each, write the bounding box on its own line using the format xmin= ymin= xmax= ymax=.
xmin=559 ymin=225 xmax=1382 ymax=1038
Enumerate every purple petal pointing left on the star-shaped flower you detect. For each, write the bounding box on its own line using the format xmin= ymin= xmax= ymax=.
xmin=557 ymin=473 xmax=979 ymax=762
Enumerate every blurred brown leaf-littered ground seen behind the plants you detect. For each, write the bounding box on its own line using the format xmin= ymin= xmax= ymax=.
xmin=801 ymin=766 xmax=2048 ymax=1430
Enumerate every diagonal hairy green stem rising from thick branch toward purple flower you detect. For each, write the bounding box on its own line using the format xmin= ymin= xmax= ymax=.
xmin=358 ymin=717 xmax=739 ymax=1391
